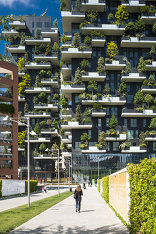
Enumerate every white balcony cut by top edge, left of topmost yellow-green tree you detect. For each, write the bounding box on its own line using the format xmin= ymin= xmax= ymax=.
xmin=81 ymin=0 xmax=106 ymax=12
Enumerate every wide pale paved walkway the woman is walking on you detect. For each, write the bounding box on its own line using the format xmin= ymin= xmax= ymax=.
xmin=10 ymin=187 xmax=129 ymax=234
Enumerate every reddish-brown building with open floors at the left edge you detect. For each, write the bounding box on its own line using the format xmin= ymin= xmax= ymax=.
xmin=0 ymin=61 xmax=18 ymax=179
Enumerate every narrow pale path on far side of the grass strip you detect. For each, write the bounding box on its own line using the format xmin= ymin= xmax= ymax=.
xmin=0 ymin=185 xmax=69 ymax=212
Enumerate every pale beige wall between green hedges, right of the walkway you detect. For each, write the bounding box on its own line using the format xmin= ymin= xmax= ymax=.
xmin=109 ymin=168 xmax=130 ymax=222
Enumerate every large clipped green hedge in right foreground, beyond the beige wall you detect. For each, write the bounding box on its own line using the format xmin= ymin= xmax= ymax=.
xmin=128 ymin=158 xmax=156 ymax=234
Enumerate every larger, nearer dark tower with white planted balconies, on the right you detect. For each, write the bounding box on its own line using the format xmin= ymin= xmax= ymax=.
xmin=61 ymin=0 xmax=156 ymax=181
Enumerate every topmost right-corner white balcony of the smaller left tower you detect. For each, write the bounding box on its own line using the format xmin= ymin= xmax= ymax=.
xmin=41 ymin=28 xmax=59 ymax=43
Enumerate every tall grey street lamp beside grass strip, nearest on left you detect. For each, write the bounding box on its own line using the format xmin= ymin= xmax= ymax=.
xmin=3 ymin=115 xmax=36 ymax=208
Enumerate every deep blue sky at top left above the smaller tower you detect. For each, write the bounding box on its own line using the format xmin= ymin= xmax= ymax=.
xmin=0 ymin=0 xmax=61 ymax=54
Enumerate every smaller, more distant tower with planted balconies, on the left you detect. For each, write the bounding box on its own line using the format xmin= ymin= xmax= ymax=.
xmin=2 ymin=16 xmax=60 ymax=180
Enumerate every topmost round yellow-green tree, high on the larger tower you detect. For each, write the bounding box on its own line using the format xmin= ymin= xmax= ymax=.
xmin=115 ymin=5 xmax=129 ymax=24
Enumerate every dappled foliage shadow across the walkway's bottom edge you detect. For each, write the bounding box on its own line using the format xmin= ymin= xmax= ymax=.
xmin=10 ymin=223 xmax=129 ymax=234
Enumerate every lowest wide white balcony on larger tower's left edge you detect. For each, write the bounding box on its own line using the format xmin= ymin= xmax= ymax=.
xmin=61 ymin=121 xmax=92 ymax=130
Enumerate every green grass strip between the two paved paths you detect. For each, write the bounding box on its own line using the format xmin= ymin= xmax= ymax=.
xmin=0 ymin=191 xmax=73 ymax=234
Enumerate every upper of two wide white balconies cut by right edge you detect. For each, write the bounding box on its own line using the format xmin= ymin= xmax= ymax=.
xmin=121 ymin=37 xmax=156 ymax=48
